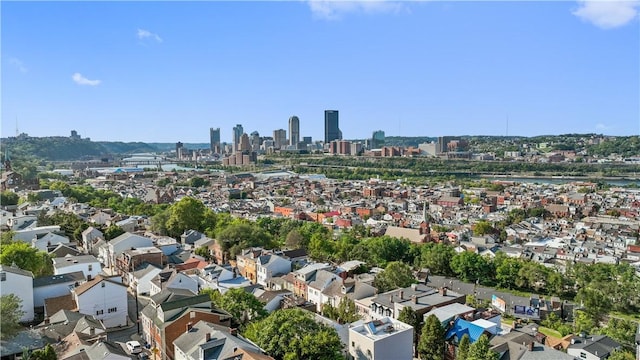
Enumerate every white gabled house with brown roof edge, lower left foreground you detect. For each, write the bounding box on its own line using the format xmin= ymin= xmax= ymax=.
xmin=71 ymin=275 xmax=128 ymax=328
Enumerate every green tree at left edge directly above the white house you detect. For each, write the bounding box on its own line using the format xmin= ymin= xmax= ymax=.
xmin=0 ymin=241 xmax=53 ymax=277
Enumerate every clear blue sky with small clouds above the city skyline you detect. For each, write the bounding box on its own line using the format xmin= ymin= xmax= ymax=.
xmin=1 ymin=0 xmax=640 ymax=142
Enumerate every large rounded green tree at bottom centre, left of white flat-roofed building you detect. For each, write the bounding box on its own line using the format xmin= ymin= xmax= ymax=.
xmin=244 ymin=309 xmax=342 ymax=360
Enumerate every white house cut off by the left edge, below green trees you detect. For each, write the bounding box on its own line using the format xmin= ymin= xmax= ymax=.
xmin=0 ymin=265 xmax=34 ymax=322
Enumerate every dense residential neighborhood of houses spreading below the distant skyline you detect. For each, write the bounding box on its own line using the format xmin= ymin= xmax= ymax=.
xmin=0 ymin=167 xmax=640 ymax=360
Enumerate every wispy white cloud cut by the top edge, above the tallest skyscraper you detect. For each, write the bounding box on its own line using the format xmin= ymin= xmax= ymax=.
xmin=308 ymin=0 xmax=407 ymax=20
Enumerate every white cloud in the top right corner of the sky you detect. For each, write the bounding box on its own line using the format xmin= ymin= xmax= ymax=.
xmin=573 ymin=0 xmax=640 ymax=29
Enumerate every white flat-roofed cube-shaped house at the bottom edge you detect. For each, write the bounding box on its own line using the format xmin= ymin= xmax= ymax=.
xmin=349 ymin=317 xmax=413 ymax=360
